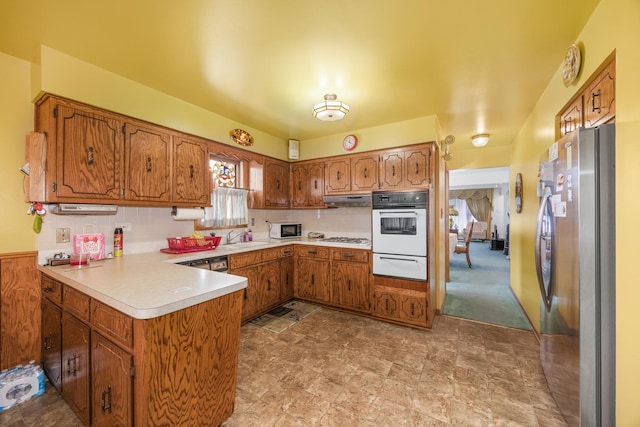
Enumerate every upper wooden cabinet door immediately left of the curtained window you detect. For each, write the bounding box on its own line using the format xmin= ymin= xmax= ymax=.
xmin=173 ymin=136 xmax=211 ymax=206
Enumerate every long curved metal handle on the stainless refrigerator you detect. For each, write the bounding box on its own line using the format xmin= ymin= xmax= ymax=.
xmin=535 ymin=188 xmax=555 ymax=311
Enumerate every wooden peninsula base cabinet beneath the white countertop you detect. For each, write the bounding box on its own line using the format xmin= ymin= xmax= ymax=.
xmin=41 ymin=274 xmax=243 ymax=426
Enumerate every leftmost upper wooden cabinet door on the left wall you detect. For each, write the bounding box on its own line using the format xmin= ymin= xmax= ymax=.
xmin=55 ymin=104 xmax=123 ymax=201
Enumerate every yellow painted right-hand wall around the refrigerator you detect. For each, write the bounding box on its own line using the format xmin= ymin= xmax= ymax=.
xmin=510 ymin=0 xmax=640 ymax=426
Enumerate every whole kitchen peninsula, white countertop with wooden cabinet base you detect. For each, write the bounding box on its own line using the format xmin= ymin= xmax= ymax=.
xmin=38 ymin=253 xmax=247 ymax=426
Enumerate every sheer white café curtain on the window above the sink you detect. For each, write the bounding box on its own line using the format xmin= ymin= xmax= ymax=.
xmin=204 ymin=187 xmax=249 ymax=227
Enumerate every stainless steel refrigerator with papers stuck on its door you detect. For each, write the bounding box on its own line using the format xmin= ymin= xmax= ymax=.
xmin=535 ymin=124 xmax=615 ymax=426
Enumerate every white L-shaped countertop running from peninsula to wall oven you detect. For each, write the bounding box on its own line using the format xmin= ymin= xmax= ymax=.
xmin=38 ymin=238 xmax=371 ymax=319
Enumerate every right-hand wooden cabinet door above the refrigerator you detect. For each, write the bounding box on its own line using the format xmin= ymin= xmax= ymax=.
xmin=584 ymin=60 xmax=616 ymax=128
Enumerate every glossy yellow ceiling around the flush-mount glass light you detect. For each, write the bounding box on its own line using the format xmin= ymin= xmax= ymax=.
xmin=0 ymin=0 xmax=599 ymax=148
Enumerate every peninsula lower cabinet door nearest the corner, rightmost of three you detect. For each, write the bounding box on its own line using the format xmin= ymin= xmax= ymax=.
xmin=91 ymin=332 xmax=133 ymax=427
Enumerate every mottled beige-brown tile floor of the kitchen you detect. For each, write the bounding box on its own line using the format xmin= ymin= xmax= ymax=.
xmin=0 ymin=309 xmax=565 ymax=427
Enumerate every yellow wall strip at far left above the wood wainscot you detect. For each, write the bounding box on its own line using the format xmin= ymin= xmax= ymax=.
xmin=0 ymin=53 xmax=37 ymax=253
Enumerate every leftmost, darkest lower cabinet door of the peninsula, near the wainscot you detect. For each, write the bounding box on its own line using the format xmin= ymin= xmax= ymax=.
xmin=42 ymin=298 xmax=62 ymax=391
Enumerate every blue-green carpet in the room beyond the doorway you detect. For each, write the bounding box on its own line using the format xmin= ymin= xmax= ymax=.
xmin=442 ymin=241 xmax=531 ymax=330
